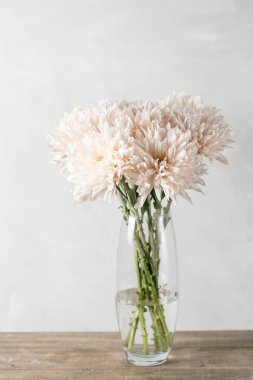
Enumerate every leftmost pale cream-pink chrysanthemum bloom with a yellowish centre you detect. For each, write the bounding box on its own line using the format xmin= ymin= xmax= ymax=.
xmin=49 ymin=102 xmax=133 ymax=201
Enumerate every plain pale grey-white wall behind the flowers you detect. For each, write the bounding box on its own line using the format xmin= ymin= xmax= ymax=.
xmin=0 ymin=0 xmax=253 ymax=331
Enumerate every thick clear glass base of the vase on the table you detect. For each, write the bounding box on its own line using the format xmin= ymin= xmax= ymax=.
xmin=125 ymin=351 xmax=169 ymax=367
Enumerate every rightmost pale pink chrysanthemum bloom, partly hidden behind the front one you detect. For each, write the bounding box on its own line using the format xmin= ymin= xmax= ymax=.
xmin=161 ymin=95 xmax=234 ymax=163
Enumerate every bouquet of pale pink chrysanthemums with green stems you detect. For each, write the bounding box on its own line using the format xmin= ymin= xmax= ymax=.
xmin=49 ymin=95 xmax=233 ymax=365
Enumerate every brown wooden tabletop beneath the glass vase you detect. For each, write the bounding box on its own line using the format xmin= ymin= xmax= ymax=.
xmin=0 ymin=331 xmax=253 ymax=380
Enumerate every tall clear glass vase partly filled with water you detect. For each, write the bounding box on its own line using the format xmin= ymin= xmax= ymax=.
xmin=116 ymin=214 xmax=178 ymax=366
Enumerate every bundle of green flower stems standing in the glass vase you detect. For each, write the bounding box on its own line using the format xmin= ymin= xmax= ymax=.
xmin=117 ymin=178 xmax=173 ymax=354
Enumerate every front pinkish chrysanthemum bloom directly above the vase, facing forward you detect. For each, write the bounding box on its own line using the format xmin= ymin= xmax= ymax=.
xmin=127 ymin=121 xmax=206 ymax=206
